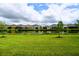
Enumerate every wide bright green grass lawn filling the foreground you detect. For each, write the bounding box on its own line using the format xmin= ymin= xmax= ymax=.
xmin=0 ymin=35 xmax=79 ymax=56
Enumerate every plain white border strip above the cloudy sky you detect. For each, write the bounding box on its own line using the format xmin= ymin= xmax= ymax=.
xmin=0 ymin=0 xmax=79 ymax=3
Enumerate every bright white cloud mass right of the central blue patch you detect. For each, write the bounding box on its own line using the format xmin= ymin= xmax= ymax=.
xmin=42 ymin=3 xmax=79 ymax=24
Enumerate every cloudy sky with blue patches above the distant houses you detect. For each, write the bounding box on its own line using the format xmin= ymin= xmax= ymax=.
xmin=0 ymin=3 xmax=79 ymax=25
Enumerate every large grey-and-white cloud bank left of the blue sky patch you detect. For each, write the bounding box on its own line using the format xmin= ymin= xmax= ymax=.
xmin=0 ymin=4 xmax=40 ymax=22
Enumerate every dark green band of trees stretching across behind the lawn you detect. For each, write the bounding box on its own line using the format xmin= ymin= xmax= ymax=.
xmin=0 ymin=20 xmax=79 ymax=34
